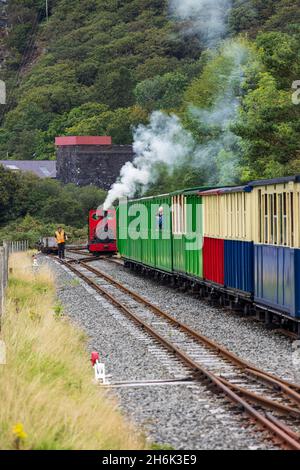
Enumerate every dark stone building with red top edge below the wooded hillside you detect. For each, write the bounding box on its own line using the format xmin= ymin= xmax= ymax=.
xmin=55 ymin=136 xmax=133 ymax=190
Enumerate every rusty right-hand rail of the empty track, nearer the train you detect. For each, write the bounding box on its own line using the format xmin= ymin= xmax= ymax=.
xmin=78 ymin=260 xmax=300 ymax=396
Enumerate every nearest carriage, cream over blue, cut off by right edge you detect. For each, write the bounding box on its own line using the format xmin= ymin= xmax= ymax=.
xmin=250 ymin=176 xmax=300 ymax=319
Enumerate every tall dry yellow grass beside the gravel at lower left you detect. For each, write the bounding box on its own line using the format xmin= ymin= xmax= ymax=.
xmin=0 ymin=254 xmax=144 ymax=450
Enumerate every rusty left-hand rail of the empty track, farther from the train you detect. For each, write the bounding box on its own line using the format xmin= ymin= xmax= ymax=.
xmin=60 ymin=260 xmax=300 ymax=450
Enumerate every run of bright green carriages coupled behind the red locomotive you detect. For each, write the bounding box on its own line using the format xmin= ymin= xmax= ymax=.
xmin=117 ymin=188 xmax=203 ymax=278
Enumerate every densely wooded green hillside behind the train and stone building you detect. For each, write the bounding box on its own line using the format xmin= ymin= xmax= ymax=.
xmin=0 ymin=0 xmax=300 ymax=189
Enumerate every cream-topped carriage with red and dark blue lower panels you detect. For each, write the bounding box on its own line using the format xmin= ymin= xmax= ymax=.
xmin=201 ymin=186 xmax=254 ymax=299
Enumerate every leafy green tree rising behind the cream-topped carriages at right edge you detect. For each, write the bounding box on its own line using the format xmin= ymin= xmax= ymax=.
xmin=234 ymin=72 xmax=300 ymax=180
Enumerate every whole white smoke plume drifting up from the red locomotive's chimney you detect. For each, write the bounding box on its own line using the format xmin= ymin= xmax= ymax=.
xmin=104 ymin=0 xmax=247 ymax=209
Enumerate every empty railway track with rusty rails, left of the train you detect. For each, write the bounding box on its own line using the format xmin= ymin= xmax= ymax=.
xmin=56 ymin=258 xmax=300 ymax=450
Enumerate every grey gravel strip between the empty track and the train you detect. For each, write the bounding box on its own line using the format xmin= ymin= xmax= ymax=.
xmin=92 ymin=260 xmax=296 ymax=381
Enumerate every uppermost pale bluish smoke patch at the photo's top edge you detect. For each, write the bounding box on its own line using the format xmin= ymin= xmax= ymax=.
xmin=169 ymin=0 xmax=232 ymax=46
